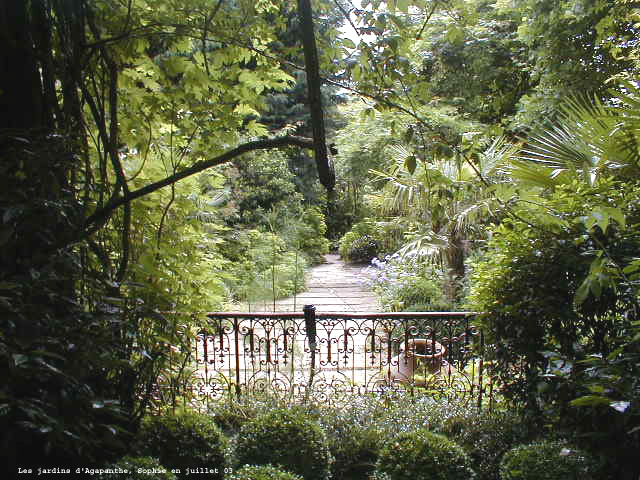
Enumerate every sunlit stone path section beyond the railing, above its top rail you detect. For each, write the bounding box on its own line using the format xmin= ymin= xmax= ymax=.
xmin=251 ymin=254 xmax=380 ymax=313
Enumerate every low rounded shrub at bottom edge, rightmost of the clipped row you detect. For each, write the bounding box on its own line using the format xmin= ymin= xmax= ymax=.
xmin=500 ymin=442 xmax=595 ymax=480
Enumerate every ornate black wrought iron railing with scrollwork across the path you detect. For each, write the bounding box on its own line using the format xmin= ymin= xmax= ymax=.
xmin=156 ymin=306 xmax=492 ymax=407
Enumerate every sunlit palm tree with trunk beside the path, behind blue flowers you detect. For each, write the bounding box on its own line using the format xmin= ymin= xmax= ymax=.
xmin=371 ymin=138 xmax=515 ymax=301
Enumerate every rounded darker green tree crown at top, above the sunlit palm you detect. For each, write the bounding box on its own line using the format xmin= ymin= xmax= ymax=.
xmin=415 ymin=2 xmax=532 ymax=124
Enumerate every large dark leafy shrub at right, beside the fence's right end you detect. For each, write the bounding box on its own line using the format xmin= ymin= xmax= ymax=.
xmin=470 ymin=179 xmax=640 ymax=477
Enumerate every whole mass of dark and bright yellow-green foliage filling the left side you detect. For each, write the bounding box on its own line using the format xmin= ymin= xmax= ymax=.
xmin=0 ymin=0 xmax=324 ymax=465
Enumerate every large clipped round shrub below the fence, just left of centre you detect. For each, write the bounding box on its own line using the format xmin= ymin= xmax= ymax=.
xmin=236 ymin=409 xmax=332 ymax=480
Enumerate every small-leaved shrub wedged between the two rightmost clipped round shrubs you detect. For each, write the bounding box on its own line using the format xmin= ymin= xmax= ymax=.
xmin=440 ymin=411 xmax=529 ymax=480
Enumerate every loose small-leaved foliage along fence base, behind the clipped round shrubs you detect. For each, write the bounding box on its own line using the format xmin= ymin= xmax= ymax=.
xmin=211 ymin=392 xmax=468 ymax=480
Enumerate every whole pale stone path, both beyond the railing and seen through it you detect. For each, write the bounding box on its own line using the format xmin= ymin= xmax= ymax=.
xmin=198 ymin=254 xmax=381 ymax=396
